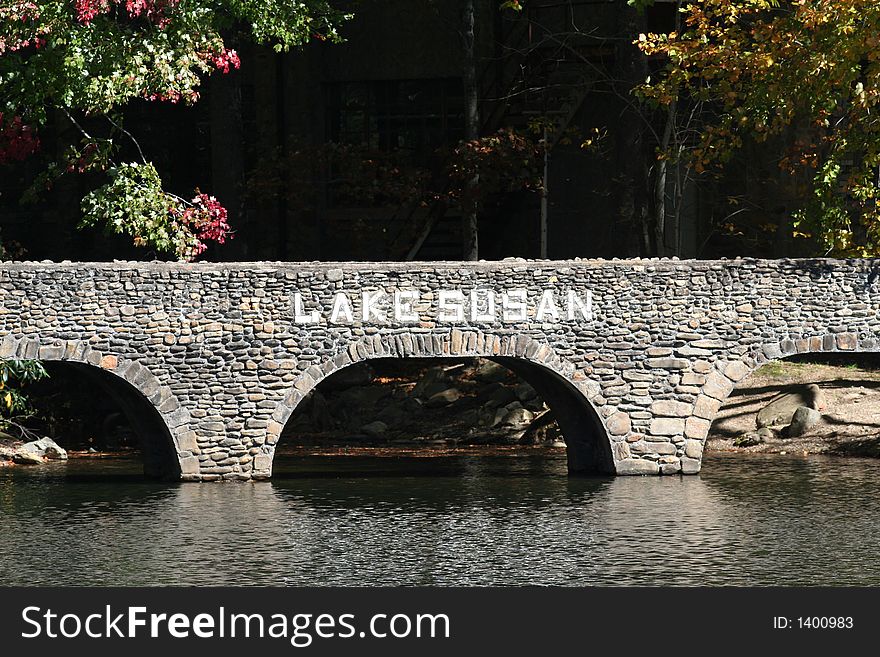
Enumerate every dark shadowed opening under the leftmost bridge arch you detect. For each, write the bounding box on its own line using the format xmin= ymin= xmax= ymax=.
xmin=0 ymin=360 xmax=180 ymax=480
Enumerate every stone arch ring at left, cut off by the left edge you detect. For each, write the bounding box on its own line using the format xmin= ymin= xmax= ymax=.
xmin=0 ymin=335 xmax=191 ymax=479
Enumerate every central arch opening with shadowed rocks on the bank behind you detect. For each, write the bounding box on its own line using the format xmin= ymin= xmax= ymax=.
xmin=278 ymin=356 xmax=614 ymax=474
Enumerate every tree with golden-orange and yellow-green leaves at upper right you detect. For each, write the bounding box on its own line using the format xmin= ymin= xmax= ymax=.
xmin=639 ymin=0 xmax=880 ymax=257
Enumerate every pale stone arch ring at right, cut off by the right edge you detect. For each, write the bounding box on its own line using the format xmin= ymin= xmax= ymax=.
xmin=682 ymin=331 xmax=880 ymax=472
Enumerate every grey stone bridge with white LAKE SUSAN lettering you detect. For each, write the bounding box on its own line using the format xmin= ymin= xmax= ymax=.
xmin=0 ymin=259 xmax=880 ymax=481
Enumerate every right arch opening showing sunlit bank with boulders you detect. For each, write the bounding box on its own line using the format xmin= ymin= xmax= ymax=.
xmin=704 ymin=351 xmax=880 ymax=458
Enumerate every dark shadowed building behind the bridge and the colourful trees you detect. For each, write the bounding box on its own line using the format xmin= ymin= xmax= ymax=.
xmin=0 ymin=0 xmax=796 ymax=260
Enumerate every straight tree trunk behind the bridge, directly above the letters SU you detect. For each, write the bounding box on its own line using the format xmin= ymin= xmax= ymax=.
xmin=462 ymin=0 xmax=480 ymax=260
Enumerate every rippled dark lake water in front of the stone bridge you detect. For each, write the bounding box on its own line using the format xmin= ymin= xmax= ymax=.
xmin=0 ymin=452 xmax=880 ymax=585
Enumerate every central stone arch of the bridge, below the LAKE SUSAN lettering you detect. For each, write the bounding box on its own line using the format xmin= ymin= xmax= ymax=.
xmin=254 ymin=329 xmax=623 ymax=479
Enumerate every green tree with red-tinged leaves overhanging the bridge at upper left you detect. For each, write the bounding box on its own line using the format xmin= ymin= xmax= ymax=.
xmin=0 ymin=0 xmax=347 ymax=259
